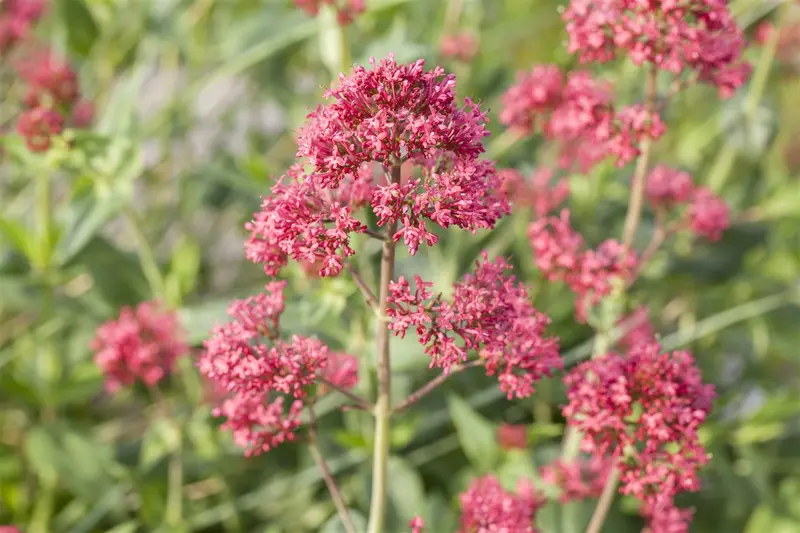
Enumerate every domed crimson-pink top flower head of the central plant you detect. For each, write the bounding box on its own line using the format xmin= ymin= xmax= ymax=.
xmin=297 ymin=55 xmax=489 ymax=188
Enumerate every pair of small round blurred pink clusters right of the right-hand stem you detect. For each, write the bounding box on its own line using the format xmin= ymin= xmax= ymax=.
xmin=645 ymin=165 xmax=730 ymax=241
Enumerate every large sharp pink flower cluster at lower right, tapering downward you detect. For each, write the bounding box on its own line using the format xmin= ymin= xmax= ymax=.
xmin=563 ymin=341 xmax=714 ymax=524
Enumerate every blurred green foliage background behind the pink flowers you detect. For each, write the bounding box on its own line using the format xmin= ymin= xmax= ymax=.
xmin=0 ymin=0 xmax=800 ymax=533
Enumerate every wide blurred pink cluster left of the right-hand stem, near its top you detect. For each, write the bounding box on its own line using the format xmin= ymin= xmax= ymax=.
xmin=500 ymin=65 xmax=665 ymax=169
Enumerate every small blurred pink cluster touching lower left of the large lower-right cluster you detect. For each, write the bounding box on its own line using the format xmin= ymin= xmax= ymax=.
xmin=539 ymin=456 xmax=614 ymax=503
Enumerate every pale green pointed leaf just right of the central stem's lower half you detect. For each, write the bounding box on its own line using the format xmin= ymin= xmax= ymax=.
xmin=448 ymin=396 xmax=500 ymax=472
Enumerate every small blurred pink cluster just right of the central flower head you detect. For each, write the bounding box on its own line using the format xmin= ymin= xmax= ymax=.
xmin=498 ymin=168 xmax=569 ymax=218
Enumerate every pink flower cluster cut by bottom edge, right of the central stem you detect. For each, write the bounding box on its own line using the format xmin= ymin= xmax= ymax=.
xmin=459 ymin=475 xmax=544 ymax=533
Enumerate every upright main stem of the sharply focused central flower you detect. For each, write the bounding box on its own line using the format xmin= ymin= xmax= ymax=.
xmin=367 ymin=161 xmax=400 ymax=533
